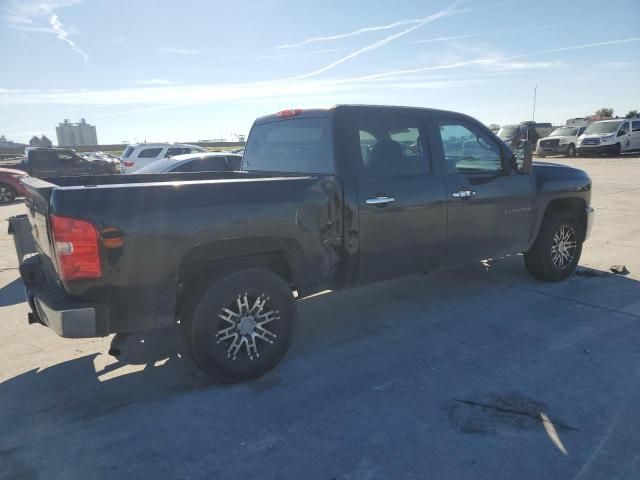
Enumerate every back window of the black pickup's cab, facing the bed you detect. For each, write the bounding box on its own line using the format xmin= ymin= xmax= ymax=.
xmin=242 ymin=118 xmax=334 ymax=173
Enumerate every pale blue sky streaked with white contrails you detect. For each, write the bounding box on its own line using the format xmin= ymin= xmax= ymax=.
xmin=0 ymin=0 xmax=640 ymax=143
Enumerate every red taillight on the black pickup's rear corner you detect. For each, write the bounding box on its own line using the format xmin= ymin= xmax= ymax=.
xmin=51 ymin=215 xmax=102 ymax=280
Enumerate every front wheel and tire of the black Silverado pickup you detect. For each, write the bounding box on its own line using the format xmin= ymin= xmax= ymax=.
xmin=524 ymin=212 xmax=584 ymax=282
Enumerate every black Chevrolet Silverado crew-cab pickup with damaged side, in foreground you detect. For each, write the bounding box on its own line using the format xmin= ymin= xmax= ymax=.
xmin=10 ymin=105 xmax=593 ymax=382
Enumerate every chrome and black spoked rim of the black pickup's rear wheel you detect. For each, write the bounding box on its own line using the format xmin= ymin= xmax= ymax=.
xmin=216 ymin=292 xmax=280 ymax=360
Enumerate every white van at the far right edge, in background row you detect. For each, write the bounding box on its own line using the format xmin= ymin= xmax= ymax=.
xmin=578 ymin=118 xmax=640 ymax=155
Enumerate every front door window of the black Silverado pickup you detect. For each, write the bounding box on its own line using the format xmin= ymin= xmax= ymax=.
xmin=440 ymin=122 xmax=503 ymax=173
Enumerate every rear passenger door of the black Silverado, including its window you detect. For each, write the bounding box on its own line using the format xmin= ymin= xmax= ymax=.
xmin=348 ymin=107 xmax=446 ymax=283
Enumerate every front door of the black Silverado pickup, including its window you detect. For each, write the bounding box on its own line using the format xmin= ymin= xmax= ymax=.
xmin=432 ymin=113 xmax=535 ymax=265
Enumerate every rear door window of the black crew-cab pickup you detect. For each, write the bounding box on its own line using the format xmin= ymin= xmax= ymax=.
xmin=358 ymin=115 xmax=431 ymax=177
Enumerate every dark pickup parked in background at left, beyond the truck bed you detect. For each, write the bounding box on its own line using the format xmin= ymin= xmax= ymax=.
xmin=24 ymin=147 xmax=119 ymax=178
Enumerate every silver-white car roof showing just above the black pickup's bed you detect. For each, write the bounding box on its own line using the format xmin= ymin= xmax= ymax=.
xmin=134 ymin=152 xmax=242 ymax=174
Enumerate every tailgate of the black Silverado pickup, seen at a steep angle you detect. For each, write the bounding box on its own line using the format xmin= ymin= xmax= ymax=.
xmin=14 ymin=177 xmax=56 ymax=263
